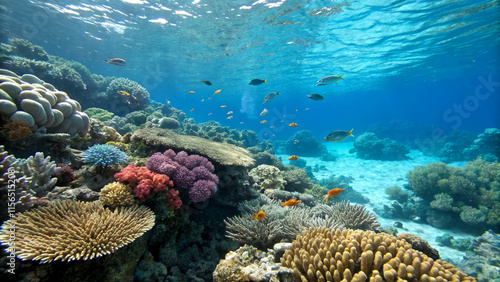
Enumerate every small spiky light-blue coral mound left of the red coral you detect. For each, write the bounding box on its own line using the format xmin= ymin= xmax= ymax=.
xmin=82 ymin=145 xmax=129 ymax=166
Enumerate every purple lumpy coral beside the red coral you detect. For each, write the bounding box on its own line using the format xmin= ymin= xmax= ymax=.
xmin=146 ymin=149 xmax=219 ymax=203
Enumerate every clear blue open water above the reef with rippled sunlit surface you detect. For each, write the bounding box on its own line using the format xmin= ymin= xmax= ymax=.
xmin=1 ymin=0 xmax=500 ymax=139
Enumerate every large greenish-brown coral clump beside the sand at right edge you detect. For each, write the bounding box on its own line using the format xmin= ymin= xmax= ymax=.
xmin=407 ymin=158 xmax=500 ymax=231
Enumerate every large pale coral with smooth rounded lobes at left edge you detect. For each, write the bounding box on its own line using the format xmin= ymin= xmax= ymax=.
xmin=0 ymin=69 xmax=90 ymax=137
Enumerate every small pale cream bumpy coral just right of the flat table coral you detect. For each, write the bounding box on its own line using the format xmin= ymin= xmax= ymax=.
xmin=248 ymin=164 xmax=286 ymax=192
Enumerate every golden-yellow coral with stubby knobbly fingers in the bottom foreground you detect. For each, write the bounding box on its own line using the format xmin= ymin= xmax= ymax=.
xmin=281 ymin=227 xmax=475 ymax=282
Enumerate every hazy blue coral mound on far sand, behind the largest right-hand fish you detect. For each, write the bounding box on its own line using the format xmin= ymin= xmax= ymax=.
xmin=354 ymin=132 xmax=410 ymax=161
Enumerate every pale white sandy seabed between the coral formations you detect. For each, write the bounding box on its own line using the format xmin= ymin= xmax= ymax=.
xmin=277 ymin=142 xmax=475 ymax=262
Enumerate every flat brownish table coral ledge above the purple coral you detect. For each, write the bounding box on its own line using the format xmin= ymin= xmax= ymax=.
xmin=132 ymin=128 xmax=255 ymax=166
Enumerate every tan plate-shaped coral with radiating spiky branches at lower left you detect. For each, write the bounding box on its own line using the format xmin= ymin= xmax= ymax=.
xmin=0 ymin=200 xmax=155 ymax=263
